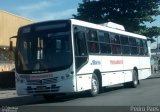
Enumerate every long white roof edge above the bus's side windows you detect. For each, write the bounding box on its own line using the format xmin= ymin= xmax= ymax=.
xmin=70 ymin=19 xmax=147 ymax=39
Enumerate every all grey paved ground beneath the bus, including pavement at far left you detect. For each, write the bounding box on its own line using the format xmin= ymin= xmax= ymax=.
xmin=0 ymin=74 xmax=160 ymax=112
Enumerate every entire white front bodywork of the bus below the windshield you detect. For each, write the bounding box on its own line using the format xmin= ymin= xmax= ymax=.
xmin=16 ymin=67 xmax=77 ymax=95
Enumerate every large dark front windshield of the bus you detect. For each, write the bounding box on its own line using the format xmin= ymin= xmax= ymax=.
xmin=16 ymin=21 xmax=72 ymax=73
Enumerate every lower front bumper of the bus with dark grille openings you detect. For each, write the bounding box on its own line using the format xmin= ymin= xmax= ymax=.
xmin=16 ymin=78 xmax=76 ymax=96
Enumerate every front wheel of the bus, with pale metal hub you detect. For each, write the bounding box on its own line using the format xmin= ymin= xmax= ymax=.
xmin=89 ymin=73 xmax=99 ymax=97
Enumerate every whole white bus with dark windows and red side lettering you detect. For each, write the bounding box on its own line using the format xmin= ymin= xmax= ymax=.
xmin=15 ymin=19 xmax=151 ymax=98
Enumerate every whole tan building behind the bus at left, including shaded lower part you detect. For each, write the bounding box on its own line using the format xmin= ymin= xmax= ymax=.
xmin=0 ymin=10 xmax=33 ymax=72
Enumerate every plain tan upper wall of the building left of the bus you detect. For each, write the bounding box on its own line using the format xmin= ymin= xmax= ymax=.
xmin=0 ymin=11 xmax=33 ymax=47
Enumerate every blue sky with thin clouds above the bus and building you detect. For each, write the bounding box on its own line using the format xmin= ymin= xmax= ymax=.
xmin=0 ymin=0 xmax=160 ymax=47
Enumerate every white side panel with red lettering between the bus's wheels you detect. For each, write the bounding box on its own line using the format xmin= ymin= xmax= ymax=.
xmin=101 ymin=56 xmax=124 ymax=86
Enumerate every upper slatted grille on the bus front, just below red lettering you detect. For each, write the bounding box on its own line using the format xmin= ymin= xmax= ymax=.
xmin=27 ymin=77 xmax=58 ymax=85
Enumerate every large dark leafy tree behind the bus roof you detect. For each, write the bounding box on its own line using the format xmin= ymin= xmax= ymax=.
xmin=73 ymin=0 xmax=160 ymax=38
